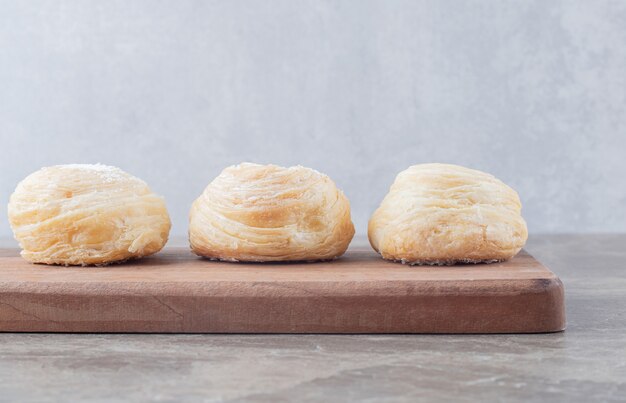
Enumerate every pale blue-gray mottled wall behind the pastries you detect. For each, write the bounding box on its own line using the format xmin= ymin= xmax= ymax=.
xmin=0 ymin=0 xmax=626 ymax=240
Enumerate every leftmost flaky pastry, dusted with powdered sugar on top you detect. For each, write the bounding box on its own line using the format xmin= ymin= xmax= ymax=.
xmin=8 ymin=164 xmax=170 ymax=265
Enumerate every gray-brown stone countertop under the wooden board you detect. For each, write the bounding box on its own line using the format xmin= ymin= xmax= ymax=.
xmin=0 ymin=235 xmax=626 ymax=402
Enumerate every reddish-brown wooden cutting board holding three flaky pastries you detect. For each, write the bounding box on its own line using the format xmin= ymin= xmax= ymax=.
xmin=0 ymin=248 xmax=565 ymax=333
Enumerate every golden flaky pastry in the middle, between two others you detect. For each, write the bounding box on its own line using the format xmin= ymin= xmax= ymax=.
xmin=189 ymin=163 xmax=354 ymax=262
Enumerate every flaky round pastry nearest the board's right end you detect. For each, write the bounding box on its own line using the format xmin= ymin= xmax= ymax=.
xmin=368 ymin=164 xmax=528 ymax=264
